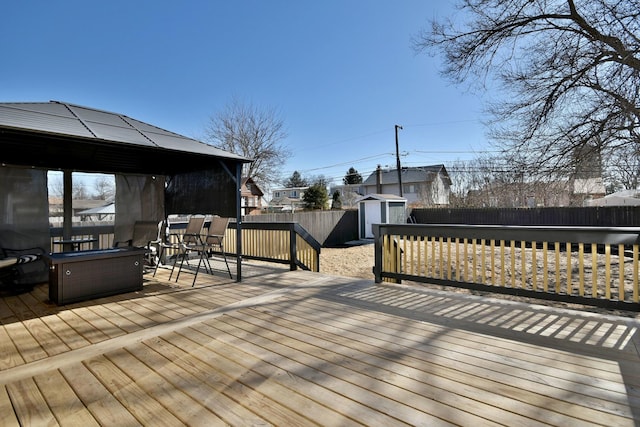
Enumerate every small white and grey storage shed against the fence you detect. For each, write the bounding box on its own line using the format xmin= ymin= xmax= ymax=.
xmin=356 ymin=194 xmax=407 ymax=239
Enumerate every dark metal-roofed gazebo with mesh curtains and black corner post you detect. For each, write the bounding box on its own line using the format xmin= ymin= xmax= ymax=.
xmin=0 ymin=101 xmax=251 ymax=281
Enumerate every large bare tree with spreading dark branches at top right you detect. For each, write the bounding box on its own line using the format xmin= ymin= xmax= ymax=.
xmin=414 ymin=0 xmax=640 ymax=175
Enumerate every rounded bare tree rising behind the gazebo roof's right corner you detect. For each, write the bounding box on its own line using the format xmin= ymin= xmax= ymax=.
xmin=205 ymin=99 xmax=290 ymax=188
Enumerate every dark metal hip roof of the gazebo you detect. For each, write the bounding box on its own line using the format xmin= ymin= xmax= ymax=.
xmin=0 ymin=101 xmax=251 ymax=174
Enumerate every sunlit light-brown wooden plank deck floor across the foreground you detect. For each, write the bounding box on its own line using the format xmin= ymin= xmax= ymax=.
xmin=0 ymin=260 xmax=640 ymax=426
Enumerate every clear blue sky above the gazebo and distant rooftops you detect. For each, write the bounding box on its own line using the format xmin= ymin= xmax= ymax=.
xmin=0 ymin=0 xmax=490 ymax=188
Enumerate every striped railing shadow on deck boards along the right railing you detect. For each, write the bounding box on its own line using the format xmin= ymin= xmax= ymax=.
xmin=324 ymin=285 xmax=640 ymax=357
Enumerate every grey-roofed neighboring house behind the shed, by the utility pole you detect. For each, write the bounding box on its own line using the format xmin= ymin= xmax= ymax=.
xmin=362 ymin=165 xmax=451 ymax=207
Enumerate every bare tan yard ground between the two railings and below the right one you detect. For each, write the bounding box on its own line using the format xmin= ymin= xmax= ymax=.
xmin=320 ymin=244 xmax=640 ymax=319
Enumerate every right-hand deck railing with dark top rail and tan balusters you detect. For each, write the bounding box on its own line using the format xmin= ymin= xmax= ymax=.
xmin=374 ymin=224 xmax=640 ymax=311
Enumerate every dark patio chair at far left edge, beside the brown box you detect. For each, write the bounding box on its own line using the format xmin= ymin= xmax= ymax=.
xmin=0 ymin=247 xmax=49 ymax=295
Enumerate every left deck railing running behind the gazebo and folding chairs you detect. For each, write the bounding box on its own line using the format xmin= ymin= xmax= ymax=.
xmin=50 ymin=222 xmax=321 ymax=272
